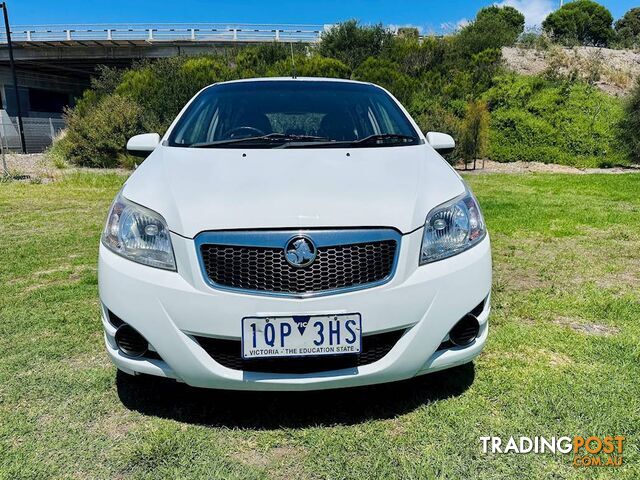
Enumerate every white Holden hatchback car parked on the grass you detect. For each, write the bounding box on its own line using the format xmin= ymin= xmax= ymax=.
xmin=99 ymin=78 xmax=491 ymax=390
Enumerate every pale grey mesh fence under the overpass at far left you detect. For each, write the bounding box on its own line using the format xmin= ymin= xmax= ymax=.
xmin=0 ymin=114 xmax=65 ymax=153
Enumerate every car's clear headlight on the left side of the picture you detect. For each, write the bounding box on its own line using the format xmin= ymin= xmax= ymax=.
xmin=102 ymin=194 xmax=176 ymax=270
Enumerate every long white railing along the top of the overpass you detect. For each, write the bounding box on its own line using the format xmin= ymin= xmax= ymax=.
xmin=0 ymin=23 xmax=329 ymax=43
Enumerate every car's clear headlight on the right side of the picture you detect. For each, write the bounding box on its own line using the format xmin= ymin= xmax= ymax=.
xmin=420 ymin=190 xmax=487 ymax=265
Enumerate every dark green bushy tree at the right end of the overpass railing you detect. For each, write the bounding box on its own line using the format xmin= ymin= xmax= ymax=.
xmin=318 ymin=20 xmax=393 ymax=69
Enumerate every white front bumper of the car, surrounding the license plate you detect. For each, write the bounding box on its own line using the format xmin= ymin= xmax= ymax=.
xmin=98 ymin=229 xmax=491 ymax=390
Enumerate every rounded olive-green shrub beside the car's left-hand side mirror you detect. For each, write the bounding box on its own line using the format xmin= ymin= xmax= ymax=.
xmin=60 ymin=94 xmax=143 ymax=167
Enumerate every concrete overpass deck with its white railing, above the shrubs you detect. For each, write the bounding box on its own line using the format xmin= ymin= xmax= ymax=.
xmin=0 ymin=23 xmax=327 ymax=73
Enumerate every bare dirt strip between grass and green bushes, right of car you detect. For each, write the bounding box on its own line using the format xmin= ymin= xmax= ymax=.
xmin=455 ymin=160 xmax=640 ymax=175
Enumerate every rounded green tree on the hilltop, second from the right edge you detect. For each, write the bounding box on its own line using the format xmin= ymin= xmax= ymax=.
xmin=542 ymin=0 xmax=614 ymax=47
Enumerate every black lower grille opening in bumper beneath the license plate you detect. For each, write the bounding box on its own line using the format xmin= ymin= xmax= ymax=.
xmin=195 ymin=330 xmax=404 ymax=373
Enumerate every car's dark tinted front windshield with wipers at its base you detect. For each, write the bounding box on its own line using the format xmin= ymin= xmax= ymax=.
xmin=169 ymin=80 xmax=420 ymax=148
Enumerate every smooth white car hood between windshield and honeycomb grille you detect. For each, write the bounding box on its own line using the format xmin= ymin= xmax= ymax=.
xmin=123 ymin=145 xmax=464 ymax=238
